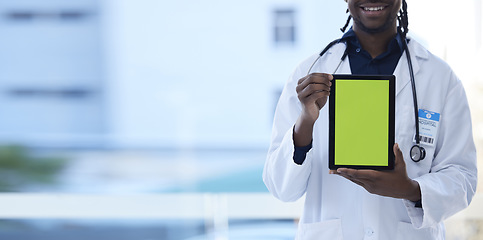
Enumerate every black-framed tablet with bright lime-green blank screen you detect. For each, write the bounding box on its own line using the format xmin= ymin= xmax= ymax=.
xmin=329 ymin=74 xmax=396 ymax=170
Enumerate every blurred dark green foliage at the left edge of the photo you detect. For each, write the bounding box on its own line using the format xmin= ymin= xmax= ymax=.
xmin=0 ymin=146 xmax=66 ymax=192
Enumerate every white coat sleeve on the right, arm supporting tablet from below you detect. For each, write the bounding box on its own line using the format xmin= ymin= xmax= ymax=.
xmin=405 ymin=74 xmax=477 ymax=228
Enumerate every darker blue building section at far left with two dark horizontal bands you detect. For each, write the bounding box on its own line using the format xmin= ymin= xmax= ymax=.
xmin=0 ymin=0 xmax=103 ymax=146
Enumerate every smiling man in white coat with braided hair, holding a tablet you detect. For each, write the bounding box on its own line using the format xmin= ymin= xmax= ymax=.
xmin=263 ymin=0 xmax=477 ymax=240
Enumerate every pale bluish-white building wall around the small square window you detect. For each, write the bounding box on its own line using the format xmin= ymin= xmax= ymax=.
xmin=104 ymin=0 xmax=345 ymax=148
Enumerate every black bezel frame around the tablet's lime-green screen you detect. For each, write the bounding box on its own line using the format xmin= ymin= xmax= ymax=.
xmin=329 ymin=74 xmax=396 ymax=170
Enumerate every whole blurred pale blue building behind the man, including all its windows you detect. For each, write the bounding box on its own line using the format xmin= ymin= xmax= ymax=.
xmin=0 ymin=0 xmax=345 ymax=149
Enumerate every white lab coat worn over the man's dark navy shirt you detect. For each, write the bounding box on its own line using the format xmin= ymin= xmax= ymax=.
xmin=263 ymin=40 xmax=477 ymax=240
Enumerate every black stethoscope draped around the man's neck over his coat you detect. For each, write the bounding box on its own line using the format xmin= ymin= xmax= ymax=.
xmin=307 ymin=30 xmax=426 ymax=162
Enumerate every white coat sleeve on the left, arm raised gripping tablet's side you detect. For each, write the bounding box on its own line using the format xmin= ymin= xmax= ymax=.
xmin=263 ymin=59 xmax=313 ymax=201
